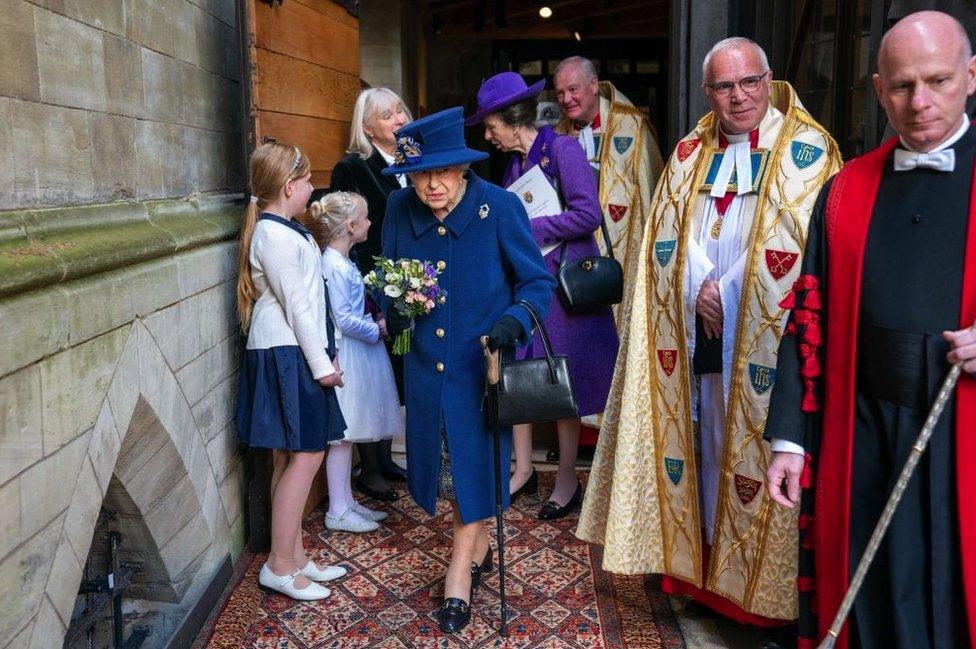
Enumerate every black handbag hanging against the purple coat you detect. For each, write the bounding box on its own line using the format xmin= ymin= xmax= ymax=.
xmin=556 ymin=219 xmax=624 ymax=311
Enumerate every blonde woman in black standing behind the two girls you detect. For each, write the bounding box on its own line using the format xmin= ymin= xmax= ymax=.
xmin=329 ymin=88 xmax=413 ymax=501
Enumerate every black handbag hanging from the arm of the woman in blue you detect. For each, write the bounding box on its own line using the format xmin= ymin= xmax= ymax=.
xmin=498 ymin=300 xmax=579 ymax=426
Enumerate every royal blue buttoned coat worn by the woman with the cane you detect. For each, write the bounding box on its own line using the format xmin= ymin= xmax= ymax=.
xmin=382 ymin=172 xmax=555 ymax=523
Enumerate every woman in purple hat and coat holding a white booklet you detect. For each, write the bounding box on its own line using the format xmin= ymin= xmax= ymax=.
xmin=465 ymin=72 xmax=618 ymax=520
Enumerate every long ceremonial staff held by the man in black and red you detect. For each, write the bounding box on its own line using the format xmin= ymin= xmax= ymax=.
xmin=817 ymin=323 xmax=976 ymax=649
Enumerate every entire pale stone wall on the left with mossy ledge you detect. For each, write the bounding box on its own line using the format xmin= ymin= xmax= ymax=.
xmin=0 ymin=0 xmax=244 ymax=649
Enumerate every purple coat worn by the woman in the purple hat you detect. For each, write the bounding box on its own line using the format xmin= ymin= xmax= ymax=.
xmin=502 ymin=126 xmax=619 ymax=417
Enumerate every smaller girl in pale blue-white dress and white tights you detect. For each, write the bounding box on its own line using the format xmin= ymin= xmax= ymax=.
xmin=310 ymin=192 xmax=403 ymax=532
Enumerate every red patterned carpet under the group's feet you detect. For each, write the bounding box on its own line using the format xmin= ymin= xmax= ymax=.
xmin=193 ymin=473 xmax=685 ymax=649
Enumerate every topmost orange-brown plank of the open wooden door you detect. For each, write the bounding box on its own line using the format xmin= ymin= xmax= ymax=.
xmin=254 ymin=2 xmax=359 ymax=76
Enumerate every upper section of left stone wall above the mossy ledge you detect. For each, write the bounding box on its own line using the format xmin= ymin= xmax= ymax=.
xmin=0 ymin=0 xmax=243 ymax=210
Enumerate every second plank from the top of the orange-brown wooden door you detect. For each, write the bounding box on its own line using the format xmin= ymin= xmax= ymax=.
xmin=254 ymin=49 xmax=360 ymax=121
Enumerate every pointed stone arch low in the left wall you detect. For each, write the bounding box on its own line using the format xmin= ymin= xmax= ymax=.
xmin=24 ymin=320 xmax=241 ymax=647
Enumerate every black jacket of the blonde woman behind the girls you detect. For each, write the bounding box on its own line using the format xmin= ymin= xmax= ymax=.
xmin=329 ymin=151 xmax=400 ymax=274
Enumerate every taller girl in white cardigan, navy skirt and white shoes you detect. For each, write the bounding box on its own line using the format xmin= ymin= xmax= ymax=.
xmin=237 ymin=143 xmax=346 ymax=600
